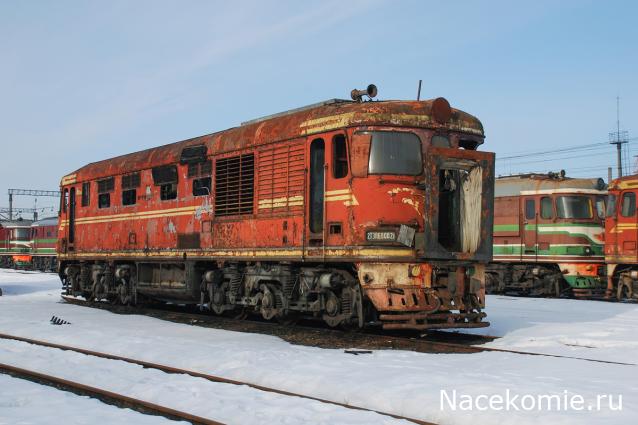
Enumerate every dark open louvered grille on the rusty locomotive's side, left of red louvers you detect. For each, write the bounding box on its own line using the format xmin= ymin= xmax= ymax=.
xmin=215 ymin=153 xmax=255 ymax=216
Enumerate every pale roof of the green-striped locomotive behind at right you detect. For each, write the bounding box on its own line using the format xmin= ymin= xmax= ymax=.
xmin=494 ymin=174 xmax=606 ymax=197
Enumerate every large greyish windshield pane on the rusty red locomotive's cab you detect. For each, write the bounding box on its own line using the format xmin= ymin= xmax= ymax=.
xmin=368 ymin=131 xmax=423 ymax=176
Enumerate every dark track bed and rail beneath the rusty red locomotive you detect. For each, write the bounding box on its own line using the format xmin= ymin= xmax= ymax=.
xmin=62 ymin=295 xmax=638 ymax=366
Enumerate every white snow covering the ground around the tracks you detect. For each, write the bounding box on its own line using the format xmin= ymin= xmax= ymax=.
xmin=0 ymin=271 xmax=638 ymax=425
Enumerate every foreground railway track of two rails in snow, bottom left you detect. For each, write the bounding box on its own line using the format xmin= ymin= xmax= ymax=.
xmin=0 ymin=333 xmax=433 ymax=425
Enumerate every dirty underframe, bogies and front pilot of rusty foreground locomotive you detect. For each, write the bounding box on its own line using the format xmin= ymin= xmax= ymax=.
xmin=59 ymin=255 xmax=489 ymax=330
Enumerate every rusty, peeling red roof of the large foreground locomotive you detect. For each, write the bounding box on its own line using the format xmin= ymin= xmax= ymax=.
xmin=61 ymin=98 xmax=484 ymax=185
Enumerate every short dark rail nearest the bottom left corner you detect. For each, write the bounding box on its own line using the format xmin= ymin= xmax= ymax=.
xmin=0 ymin=363 xmax=223 ymax=425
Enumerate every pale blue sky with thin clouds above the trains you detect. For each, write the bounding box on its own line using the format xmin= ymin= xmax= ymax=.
xmin=0 ymin=0 xmax=638 ymax=215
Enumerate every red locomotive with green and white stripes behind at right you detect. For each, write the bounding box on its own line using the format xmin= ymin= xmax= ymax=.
xmin=487 ymin=173 xmax=607 ymax=298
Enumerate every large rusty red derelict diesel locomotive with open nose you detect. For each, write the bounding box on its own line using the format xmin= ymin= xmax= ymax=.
xmin=58 ymin=88 xmax=494 ymax=329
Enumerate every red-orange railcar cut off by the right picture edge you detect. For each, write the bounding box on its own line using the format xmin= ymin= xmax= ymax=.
xmin=605 ymin=175 xmax=638 ymax=300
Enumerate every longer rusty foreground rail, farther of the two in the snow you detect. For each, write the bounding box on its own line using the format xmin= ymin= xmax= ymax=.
xmin=0 ymin=333 xmax=434 ymax=425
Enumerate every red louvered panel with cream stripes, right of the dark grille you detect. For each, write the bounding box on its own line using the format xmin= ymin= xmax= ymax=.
xmin=258 ymin=143 xmax=304 ymax=213
